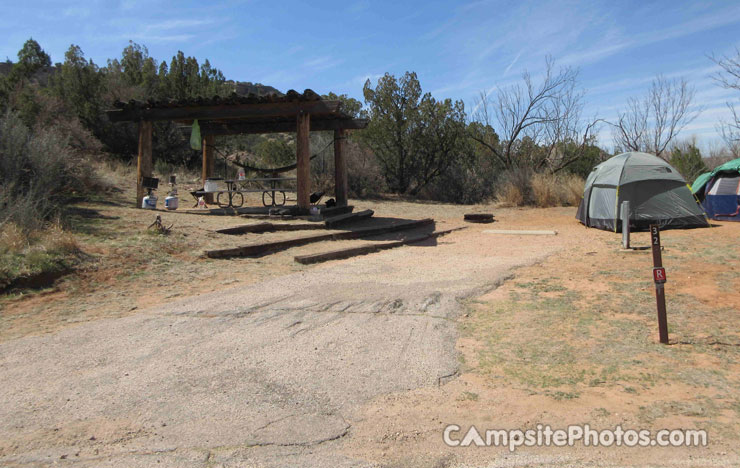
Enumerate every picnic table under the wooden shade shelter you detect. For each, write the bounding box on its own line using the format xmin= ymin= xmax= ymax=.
xmin=190 ymin=177 xmax=297 ymax=208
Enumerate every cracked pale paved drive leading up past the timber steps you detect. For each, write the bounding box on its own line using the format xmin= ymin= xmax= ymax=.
xmin=0 ymin=227 xmax=562 ymax=467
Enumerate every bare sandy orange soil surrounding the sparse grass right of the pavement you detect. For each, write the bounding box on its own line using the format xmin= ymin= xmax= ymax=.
xmin=344 ymin=209 xmax=740 ymax=467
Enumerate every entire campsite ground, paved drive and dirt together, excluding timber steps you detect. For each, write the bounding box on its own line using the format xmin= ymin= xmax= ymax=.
xmin=0 ymin=192 xmax=740 ymax=467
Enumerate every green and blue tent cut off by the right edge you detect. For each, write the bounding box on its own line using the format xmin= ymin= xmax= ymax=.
xmin=691 ymin=158 xmax=740 ymax=221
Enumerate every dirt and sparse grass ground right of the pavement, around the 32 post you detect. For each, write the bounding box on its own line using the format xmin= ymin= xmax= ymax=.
xmin=342 ymin=213 xmax=740 ymax=466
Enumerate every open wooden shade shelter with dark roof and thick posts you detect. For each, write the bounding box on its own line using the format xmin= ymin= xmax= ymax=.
xmin=107 ymin=89 xmax=368 ymax=210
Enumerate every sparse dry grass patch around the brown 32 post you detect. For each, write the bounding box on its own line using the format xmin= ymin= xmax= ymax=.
xmin=463 ymin=226 xmax=740 ymax=446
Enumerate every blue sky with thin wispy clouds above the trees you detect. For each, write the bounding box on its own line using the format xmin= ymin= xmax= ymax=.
xmin=0 ymin=0 xmax=740 ymax=148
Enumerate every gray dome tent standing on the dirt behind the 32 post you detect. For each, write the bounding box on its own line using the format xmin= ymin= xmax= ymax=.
xmin=576 ymin=153 xmax=709 ymax=232
